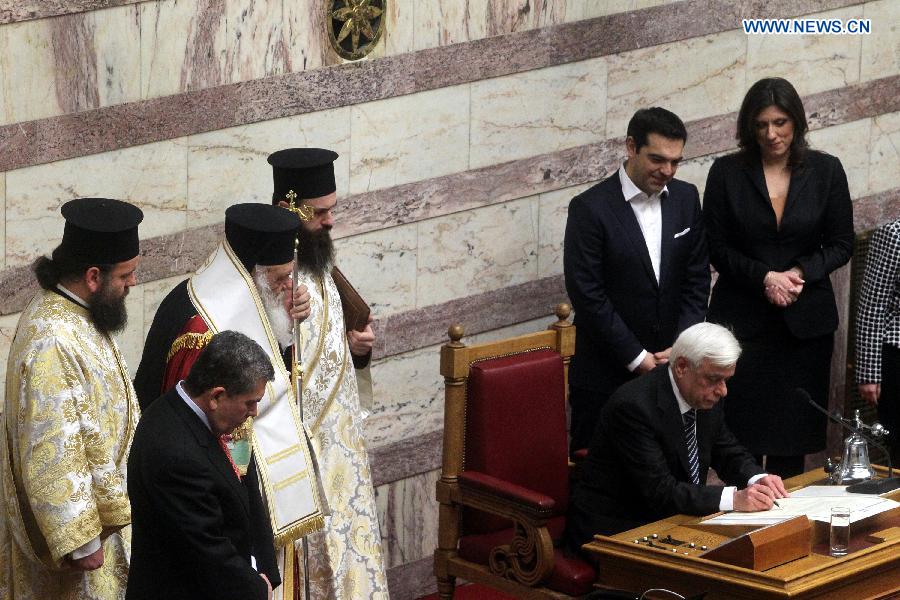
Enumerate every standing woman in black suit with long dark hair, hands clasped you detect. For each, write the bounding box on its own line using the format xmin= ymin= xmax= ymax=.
xmin=703 ymin=78 xmax=853 ymax=477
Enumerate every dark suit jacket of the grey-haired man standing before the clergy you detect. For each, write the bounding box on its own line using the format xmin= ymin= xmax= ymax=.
xmin=126 ymin=389 xmax=281 ymax=600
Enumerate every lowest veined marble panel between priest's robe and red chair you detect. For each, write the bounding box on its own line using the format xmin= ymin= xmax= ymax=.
xmin=375 ymin=470 xmax=441 ymax=568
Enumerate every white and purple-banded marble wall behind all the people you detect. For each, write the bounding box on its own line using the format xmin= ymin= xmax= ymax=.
xmin=0 ymin=0 xmax=900 ymax=598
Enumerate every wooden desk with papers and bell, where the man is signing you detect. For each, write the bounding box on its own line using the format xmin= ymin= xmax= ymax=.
xmin=585 ymin=469 xmax=900 ymax=600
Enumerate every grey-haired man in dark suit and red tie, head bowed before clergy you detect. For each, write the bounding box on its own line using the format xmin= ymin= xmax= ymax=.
xmin=126 ymin=331 xmax=281 ymax=600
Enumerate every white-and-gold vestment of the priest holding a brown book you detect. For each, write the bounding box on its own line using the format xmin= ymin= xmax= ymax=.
xmin=294 ymin=273 xmax=388 ymax=600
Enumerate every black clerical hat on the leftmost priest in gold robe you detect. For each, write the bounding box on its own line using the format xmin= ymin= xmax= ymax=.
xmin=54 ymin=198 xmax=144 ymax=265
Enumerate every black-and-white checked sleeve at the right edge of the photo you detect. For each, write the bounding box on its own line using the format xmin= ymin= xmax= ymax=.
xmin=856 ymin=221 xmax=900 ymax=383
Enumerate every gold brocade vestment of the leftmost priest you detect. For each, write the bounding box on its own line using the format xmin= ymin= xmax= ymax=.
xmin=0 ymin=291 xmax=139 ymax=600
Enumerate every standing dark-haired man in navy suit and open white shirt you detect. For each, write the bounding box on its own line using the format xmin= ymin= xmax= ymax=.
xmin=564 ymin=108 xmax=710 ymax=451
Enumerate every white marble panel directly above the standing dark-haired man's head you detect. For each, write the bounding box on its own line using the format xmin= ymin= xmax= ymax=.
xmin=606 ymin=31 xmax=747 ymax=137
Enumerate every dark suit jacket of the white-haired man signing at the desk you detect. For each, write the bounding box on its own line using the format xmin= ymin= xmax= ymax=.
xmin=567 ymin=365 xmax=764 ymax=546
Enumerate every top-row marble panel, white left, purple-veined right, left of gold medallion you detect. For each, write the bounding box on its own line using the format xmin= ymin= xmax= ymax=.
xmin=139 ymin=0 xmax=227 ymax=99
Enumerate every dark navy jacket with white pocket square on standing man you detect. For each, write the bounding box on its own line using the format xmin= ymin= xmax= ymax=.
xmin=564 ymin=173 xmax=710 ymax=393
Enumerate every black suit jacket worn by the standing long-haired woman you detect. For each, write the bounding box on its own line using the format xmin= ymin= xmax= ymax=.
xmin=703 ymin=150 xmax=853 ymax=339
